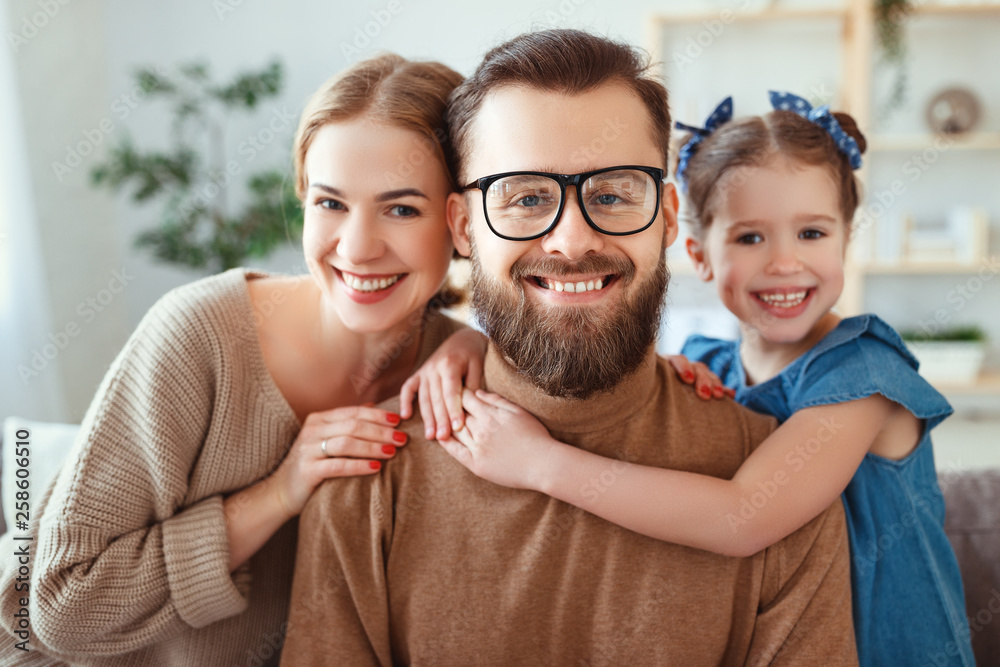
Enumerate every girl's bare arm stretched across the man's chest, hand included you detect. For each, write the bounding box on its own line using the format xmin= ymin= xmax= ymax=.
xmin=441 ymin=391 xmax=895 ymax=557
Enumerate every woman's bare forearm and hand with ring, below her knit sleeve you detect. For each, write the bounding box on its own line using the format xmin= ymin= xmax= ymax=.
xmin=224 ymin=406 xmax=406 ymax=572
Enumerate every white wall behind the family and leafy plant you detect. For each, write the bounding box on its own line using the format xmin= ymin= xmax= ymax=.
xmin=7 ymin=0 xmax=1000 ymax=421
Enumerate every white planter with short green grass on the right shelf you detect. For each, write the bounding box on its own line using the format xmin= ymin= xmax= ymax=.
xmin=900 ymin=326 xmax=986 ymax=384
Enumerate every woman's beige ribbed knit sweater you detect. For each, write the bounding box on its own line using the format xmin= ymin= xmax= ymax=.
xmin=0 ymin=269 xmax=457 ymax=667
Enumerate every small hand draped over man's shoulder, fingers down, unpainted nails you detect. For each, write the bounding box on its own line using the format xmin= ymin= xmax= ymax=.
xmin=399 ymin=329 xmax=486 ymax=440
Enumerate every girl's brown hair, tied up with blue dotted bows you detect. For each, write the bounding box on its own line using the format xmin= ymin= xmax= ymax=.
xmin=681 ymin=111 xmax=867 ymax=239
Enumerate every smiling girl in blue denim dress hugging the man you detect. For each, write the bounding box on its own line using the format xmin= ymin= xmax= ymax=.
xmin=414 ymin=93 xmax=974 ymax=665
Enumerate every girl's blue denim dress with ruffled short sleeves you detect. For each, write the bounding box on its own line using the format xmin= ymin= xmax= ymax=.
xmin=681 ymin=315 xmax=975 ymax=667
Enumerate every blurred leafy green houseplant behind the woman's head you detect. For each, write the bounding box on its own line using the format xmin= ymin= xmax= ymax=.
xmin=91 ymin=61 xmax=302 ymax=271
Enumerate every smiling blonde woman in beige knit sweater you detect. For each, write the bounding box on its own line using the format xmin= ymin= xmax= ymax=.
xmin=0 ymin=55 xmax=461 ymax=665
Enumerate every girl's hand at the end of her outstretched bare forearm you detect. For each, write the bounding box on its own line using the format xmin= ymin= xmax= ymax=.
xmin=439 ymin=389 xmax=566 ymax=490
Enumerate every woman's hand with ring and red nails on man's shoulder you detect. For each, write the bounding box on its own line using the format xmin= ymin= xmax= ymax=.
xmin=270 ymin=405 xmax=406 ymax=518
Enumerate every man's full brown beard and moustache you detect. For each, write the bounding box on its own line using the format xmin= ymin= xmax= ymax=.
xmin=470 ymin=241 xmax=670 ymax=398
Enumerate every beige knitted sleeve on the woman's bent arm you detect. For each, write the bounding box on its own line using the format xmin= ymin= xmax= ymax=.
xmin=13 ymin=290 xmax=247 ymax=656
